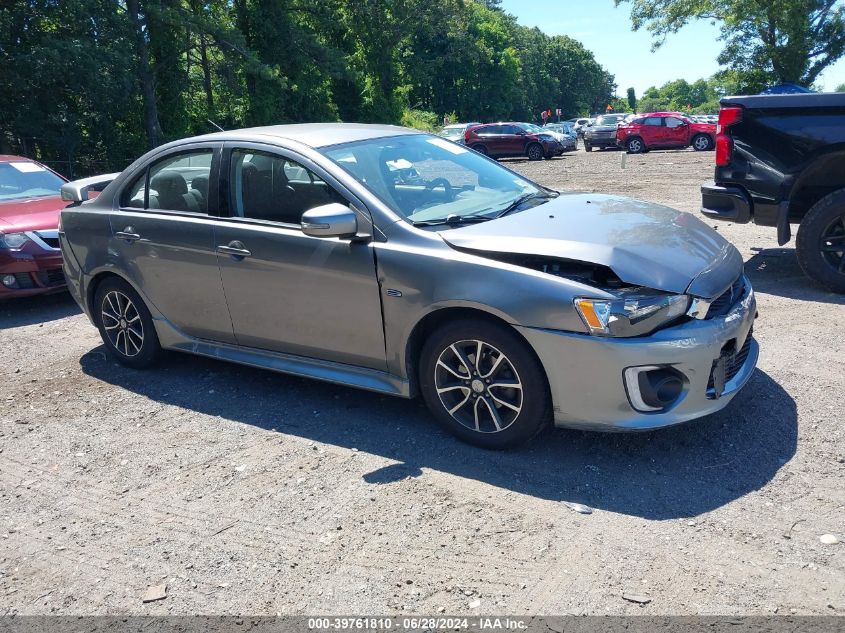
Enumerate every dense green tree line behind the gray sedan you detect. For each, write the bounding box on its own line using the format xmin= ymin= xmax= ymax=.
xmin=0 ymin=0 xmax=616 ymax=176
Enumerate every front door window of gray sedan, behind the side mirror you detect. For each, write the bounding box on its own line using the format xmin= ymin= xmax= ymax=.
xmin=229 ymin=150 xmax=346 ymax=225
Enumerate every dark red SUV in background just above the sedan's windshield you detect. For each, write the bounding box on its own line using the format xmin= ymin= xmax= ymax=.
xmin=464 ymin=123 xmax=563 ymax=160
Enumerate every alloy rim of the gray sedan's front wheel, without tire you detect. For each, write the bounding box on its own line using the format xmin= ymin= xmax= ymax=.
xmin=434 ymin=340 xmax=523 ymax=433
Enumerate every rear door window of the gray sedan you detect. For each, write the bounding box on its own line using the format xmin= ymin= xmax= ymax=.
xmin=121 ymin=149 xmax=213 ymax=213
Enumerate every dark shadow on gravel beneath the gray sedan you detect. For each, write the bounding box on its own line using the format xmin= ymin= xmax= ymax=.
xmin=80 ymin=347 xmax=797 ymax=520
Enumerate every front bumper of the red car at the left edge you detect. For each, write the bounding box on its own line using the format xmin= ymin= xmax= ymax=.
xmin=0 ymin=243 xmax=65 ymax=300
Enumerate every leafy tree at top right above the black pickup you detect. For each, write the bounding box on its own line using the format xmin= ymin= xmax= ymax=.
xmin=614 ymin=0 xmax=845 ymax=91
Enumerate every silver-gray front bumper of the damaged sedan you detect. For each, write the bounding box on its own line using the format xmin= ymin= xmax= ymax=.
xmin=518 ymin=283 xmax=759 ymax=431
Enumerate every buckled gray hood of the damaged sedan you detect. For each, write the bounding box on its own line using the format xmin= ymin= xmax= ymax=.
xmin=440 ymin=193 xmax=743 ymax=298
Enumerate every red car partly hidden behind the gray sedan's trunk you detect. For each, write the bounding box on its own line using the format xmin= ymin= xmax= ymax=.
xmin=0 ymin=155 xmax=67 ymax=300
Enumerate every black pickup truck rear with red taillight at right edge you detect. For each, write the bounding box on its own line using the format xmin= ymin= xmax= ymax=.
xmin=701 ymin=93 xmax=845 ymax=292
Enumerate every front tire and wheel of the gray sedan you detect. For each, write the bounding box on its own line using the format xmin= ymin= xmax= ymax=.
xmin=419 ymin=319 xmax=551 ymax=449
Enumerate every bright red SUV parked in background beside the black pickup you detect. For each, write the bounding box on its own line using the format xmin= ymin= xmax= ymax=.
xmin=616 ymin=112 xmax=716 ymax=154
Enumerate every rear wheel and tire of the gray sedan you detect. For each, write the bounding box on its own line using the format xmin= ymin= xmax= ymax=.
xmin=94 ymin=277 xmax=161 ymax=369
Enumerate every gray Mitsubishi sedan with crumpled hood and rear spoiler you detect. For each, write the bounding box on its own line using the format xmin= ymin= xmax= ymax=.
xmin=60 ymin=124 xmax=757 ymax=448
